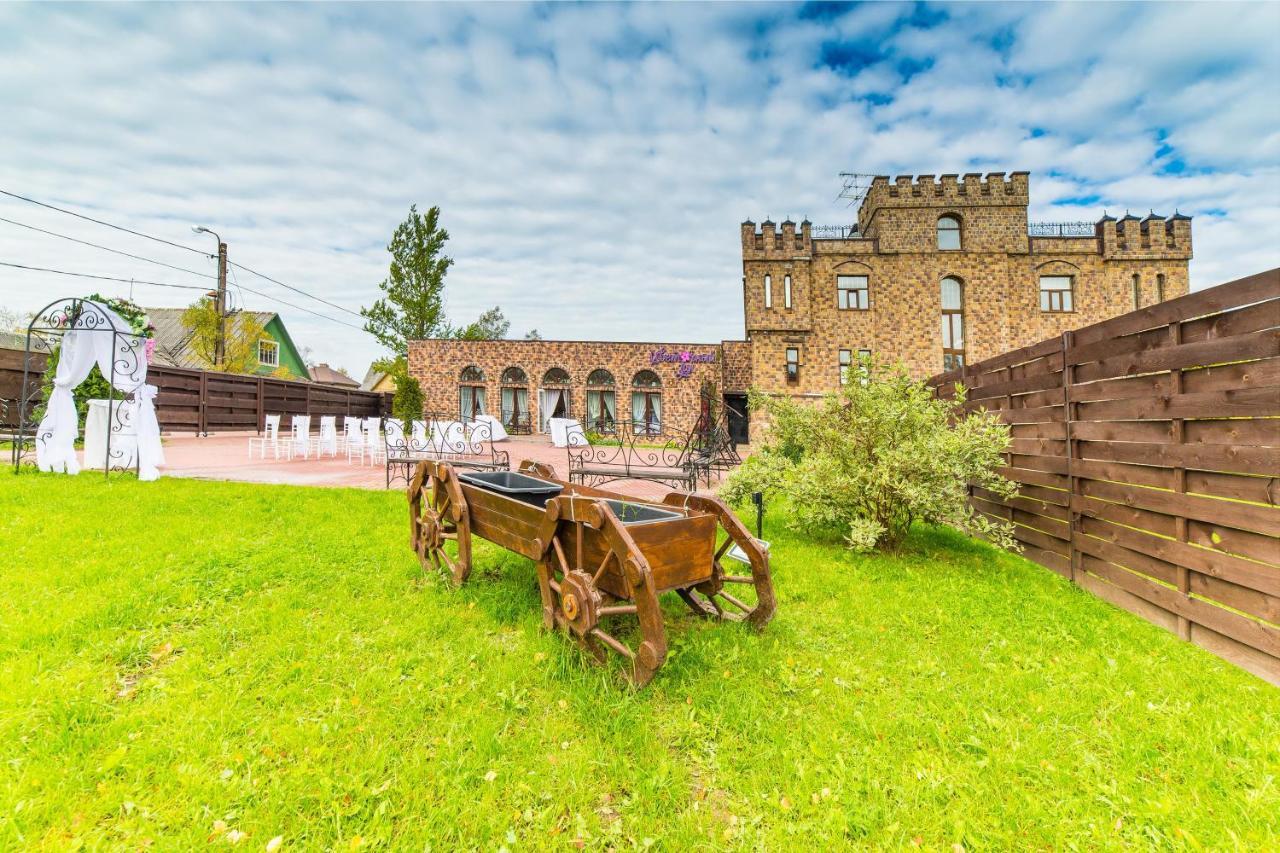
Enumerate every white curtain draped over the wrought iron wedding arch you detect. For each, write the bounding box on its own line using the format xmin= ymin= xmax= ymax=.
xmin=36 ymin=300 xmax=164 ymax=480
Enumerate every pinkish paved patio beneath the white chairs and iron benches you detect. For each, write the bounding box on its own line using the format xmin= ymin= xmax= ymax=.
xmin=145 ymin=433 xmax=717 ymax=498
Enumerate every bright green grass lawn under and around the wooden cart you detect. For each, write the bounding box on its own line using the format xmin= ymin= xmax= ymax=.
xmin=0 ymin=473 xmax=1280 ymax=852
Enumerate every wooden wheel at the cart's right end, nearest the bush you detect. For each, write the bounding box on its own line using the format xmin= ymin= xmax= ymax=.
xmin=663 ymin=492 xmax=777 ymax=628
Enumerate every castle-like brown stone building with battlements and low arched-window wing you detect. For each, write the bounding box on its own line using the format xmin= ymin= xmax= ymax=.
xmin=410 ymin=172 xmax=1192 ymax=441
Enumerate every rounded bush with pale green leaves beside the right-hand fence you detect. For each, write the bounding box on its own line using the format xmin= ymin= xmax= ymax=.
xmin=722 ymin=360 xmax=1016 ymax=551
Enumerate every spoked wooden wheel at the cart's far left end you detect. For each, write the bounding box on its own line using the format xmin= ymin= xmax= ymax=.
xmin=408 ymin=462 xmax=471 ymax=584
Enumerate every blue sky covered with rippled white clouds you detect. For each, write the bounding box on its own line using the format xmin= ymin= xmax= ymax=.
xmin=0 ymin=3 xmax=1280 ymax=378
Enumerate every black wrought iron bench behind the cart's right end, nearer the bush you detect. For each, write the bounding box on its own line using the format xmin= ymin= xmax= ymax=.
xmin=566 ymin=420 xmax=705 ymax=492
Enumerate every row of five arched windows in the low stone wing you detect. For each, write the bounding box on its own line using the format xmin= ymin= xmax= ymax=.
xmin=458 ymin=365 xmax=662 ymax=434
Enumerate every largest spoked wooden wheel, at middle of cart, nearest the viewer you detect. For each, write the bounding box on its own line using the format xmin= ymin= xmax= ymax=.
xmin=538 ymin=497 xmax=667 ymax=688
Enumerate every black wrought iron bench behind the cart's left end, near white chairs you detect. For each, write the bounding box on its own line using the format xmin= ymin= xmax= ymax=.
xmin=383 ymin=414 xmax=511 ymax=488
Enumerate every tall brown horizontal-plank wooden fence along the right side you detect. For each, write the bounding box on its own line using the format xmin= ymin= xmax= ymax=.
xmin=929 ymin=269 xmax=1280 ymax=685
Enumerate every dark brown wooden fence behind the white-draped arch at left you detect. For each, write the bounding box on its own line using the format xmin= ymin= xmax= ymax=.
xmin=0 ymin=350 xmax=392 ymax=433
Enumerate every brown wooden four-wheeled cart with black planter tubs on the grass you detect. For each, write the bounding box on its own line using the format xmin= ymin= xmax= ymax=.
xmin=408 ymin=461 xmax=776 ymax=686
